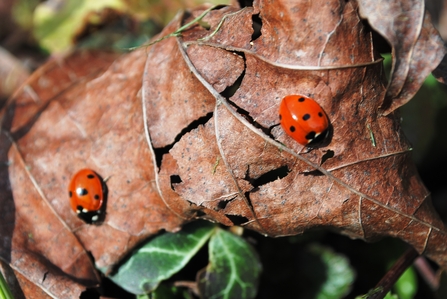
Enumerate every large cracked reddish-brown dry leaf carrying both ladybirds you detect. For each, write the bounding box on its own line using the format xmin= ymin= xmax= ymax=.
xmin=0 ymin=0 xmax=447 ymax=298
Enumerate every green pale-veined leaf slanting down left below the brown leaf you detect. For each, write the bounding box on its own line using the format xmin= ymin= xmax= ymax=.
xmin=110 ymin=222 xmax=215 ymax=294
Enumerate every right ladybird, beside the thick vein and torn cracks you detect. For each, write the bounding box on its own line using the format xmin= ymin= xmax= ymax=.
xmin=279 ymin=95 xmax=329 ymax=146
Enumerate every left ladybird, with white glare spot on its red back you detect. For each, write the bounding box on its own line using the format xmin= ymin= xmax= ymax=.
xmin=68 ymin=168 xmax=105 ymax=223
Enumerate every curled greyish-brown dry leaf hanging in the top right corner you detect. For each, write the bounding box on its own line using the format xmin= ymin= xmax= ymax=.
xmin=358 ymin=0 xmax=446 ymax=115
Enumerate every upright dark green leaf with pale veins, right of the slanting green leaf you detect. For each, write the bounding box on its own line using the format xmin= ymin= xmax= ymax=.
xmin=198 ymin=229 xmax=262 ymax=299
